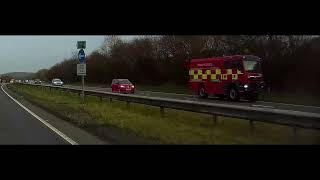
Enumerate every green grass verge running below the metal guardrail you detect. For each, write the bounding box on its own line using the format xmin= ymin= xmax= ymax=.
xmin=10 ymin=85 xmax=320 ymax=144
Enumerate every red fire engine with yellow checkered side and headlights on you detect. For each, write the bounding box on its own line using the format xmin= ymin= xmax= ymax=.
xmin=189 ymin=55 xmax=264 ymax=101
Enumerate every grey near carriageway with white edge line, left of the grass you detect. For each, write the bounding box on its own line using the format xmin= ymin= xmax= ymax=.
xmin=0 ymin=85 xmax=105 ymax=145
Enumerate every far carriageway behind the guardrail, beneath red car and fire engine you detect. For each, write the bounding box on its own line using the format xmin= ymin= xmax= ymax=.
xmin=64 ymin=85 xmax=320 ymax=113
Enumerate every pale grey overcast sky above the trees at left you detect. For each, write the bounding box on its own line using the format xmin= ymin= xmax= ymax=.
xmin=0 ymin=36 xmax=134 ymax=74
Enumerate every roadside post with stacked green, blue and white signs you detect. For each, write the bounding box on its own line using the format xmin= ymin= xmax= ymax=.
xmin=77 ymin=41 xmax=86 ymax=103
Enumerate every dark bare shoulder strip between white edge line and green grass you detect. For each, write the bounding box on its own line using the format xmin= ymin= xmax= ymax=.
xmin=6 ymin=84 xmax=161 ymax=145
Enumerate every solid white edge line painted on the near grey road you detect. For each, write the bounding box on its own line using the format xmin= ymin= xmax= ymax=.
xmin=1 ymin=85 xmax=78 ymax=145
